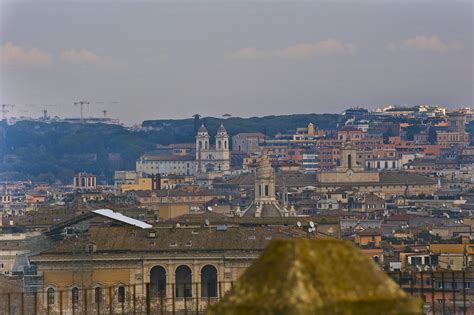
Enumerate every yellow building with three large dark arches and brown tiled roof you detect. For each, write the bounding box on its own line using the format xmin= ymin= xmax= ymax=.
xmin=30 ymin=214 xmax=338 ymax=314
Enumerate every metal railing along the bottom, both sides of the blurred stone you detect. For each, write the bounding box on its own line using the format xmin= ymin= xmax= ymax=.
xmin=0 ymin=271 xmax=474 ymax=315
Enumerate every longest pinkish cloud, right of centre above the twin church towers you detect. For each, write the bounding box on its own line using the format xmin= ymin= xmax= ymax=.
xmin=230 ymin=38 xmax=356 ymax=59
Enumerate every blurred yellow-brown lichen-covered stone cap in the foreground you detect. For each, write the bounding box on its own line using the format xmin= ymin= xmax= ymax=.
xmin=207 ymin=239 xmax=422 ymax=315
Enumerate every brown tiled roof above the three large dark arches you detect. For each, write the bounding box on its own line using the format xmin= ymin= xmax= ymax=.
xmin=32 ymin=226 xmax=317 ymax=260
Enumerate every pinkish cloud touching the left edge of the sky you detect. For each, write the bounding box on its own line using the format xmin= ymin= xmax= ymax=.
xmin=0 ymin=42 xmax=52 ymax=67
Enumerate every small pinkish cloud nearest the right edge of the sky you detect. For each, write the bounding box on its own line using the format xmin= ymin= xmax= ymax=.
xmin=388 ymin=35 xmax=463 ymax=52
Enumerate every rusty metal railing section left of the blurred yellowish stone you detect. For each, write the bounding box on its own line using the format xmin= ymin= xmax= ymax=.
xmin=0 ymin=282 xmax=233 ymax=315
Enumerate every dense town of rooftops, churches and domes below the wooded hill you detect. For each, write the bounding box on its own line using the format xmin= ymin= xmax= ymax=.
xmin=0 ymin=105 xmax=474 ymax=312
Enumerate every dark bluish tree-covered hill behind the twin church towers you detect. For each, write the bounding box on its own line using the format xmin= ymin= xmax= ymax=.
xmin=0 ymin=114 xmax=338 ymax=183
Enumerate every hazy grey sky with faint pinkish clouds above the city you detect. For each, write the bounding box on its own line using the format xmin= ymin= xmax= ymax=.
xmin=0 ymin=0 xmax=474 ymax=123
